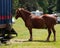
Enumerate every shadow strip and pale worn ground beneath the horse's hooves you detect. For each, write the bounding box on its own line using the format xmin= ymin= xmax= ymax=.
xmin=0 ymin=39 xmax=54 ymax=46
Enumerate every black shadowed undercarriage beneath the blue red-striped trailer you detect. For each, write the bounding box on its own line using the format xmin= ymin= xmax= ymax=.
xmin=0 ymin=24 xmax=17 ymax=43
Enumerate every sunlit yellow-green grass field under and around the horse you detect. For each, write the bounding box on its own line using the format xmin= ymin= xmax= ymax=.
xmin=0 ymin=19 xmax=60 ymax=48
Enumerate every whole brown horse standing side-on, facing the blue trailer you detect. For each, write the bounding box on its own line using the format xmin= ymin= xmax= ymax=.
xmin=15 ymin=8 xmax=56 ymax=41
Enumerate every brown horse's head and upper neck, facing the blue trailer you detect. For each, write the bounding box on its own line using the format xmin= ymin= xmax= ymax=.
xmin=15 ymin=8 xmax=31 ymax=19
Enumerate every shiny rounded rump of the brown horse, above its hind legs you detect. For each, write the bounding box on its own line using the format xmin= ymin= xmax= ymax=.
xmin=42 ymin=15 xmax=57 ymax=25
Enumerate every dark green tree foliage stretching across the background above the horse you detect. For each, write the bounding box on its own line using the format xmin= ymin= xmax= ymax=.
xmin=12 ymin=0 xmax=60 ymax=14
